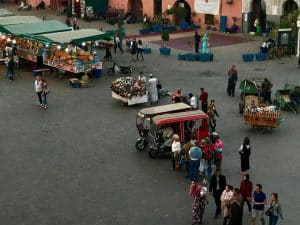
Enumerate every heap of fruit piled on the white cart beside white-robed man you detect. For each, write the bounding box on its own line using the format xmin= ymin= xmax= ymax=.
xmin=110 ymin=77 xmax=147 ymax=99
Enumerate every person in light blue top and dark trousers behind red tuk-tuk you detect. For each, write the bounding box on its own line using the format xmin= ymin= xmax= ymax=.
xmin=189 ymin=143 xmax=202 ymax=182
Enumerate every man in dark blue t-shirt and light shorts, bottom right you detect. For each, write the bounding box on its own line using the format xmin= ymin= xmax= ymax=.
xmin=251 ymin=184 xmax=266 ymax=225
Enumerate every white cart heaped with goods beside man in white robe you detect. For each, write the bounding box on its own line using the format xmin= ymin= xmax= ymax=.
xmin=110 ymin=77 xmax=148 ymax=105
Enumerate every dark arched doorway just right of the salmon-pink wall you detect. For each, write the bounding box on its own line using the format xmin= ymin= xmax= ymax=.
xmin=250 ymin=0 xmax=267 ymax=32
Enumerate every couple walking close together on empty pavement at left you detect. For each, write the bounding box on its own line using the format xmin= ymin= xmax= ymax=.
xmin=34 ymin=76 xmax=50 ymax=109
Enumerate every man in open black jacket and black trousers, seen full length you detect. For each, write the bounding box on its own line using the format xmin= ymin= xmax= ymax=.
xmin=209 ymin=169 xmax=226 ymax=218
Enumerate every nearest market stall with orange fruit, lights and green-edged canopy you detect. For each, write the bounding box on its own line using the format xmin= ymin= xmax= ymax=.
xmin=35 ymin=29 xmax=110 ymax=73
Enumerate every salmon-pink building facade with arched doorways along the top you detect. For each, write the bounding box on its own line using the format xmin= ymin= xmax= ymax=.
xmin=109 ymin=0 xmax=300 ymax=32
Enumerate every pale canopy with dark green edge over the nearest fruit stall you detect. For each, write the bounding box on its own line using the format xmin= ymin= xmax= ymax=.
xmin=33 ymin=29 xmax=113 ymax=45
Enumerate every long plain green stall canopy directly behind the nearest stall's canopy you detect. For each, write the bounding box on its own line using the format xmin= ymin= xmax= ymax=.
xmin=0 ymin=20 xmax=72 ymax=36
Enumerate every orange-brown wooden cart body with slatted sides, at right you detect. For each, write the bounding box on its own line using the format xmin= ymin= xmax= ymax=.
xmin=244 ymin=108 xmax=280 ymax=134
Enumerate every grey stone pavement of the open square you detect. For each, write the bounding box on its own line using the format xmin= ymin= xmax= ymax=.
xmin=0 ymin=2 xmax=300 ymax=225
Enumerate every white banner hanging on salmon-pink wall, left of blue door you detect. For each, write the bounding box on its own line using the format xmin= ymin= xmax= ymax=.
xmin=194 ymin=0 xmax=220 ymax=15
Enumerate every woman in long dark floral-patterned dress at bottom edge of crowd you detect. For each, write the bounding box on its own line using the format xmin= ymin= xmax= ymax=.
xmin=189 ymin=181 xmax=208 ymax=225
